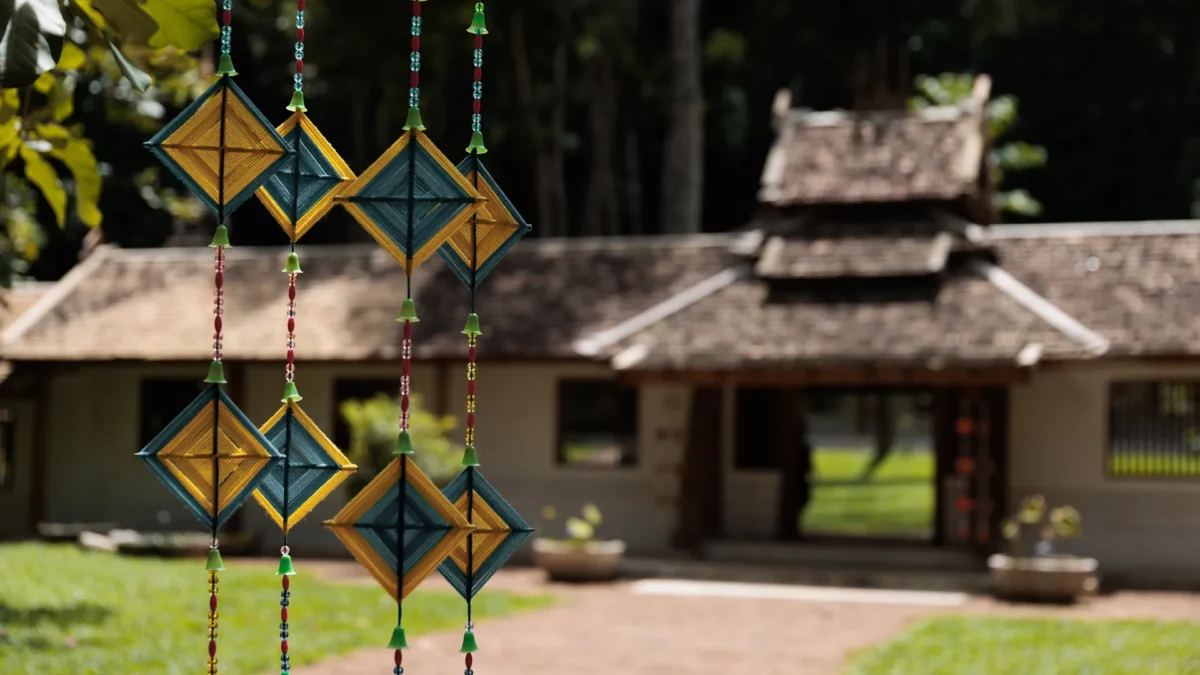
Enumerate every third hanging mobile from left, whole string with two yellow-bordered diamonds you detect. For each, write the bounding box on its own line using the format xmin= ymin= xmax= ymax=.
xmin=325 ymin=0 xmax=485 ymax=675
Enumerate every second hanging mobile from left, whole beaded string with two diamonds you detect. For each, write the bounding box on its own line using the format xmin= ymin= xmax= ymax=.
xmin=254 ymin=0 xmax=358 ymax=675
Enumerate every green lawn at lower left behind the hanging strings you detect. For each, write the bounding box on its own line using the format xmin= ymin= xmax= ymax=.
xmin=0 ymin=544 xmax=552 ymax=675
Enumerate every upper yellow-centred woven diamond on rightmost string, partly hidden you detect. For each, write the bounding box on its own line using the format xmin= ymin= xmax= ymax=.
xmin=438 ymin=155 xmax=533 ymax=288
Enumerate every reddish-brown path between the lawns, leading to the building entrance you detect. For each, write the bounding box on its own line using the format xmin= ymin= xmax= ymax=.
xmin=304 ymin=562 xmax=1200 ymax=675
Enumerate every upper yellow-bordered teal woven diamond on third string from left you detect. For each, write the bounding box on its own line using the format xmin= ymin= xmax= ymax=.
xmin=336 ymin=129 xmax=485 ymax=274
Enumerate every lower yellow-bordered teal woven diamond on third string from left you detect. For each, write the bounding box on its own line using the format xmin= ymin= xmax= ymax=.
xmin=325 ymin=455 xmax=472 ymax=601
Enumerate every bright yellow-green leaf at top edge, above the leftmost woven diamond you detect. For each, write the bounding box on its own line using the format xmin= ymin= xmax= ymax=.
xmin=76 ymin=0 xmax=220 ymax=52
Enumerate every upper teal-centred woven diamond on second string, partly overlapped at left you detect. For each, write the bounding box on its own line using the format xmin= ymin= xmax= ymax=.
xmin=250 ymin=112 xmax=354 ymax=241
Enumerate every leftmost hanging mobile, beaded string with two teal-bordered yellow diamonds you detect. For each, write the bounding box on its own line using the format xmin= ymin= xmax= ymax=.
xmin=138 ymin=0 xmax=290 ymax=675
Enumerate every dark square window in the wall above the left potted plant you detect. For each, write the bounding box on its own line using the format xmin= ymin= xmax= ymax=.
xmin=557 ymin=380 xmax=637 ymax=468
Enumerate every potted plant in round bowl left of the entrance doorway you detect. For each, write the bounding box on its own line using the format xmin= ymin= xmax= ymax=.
xmin=533 ymin=504 xmax=625 ymax=581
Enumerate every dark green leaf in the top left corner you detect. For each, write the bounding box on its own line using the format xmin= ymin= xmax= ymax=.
xmin=0 ymin=0 xmax=67 ymax=89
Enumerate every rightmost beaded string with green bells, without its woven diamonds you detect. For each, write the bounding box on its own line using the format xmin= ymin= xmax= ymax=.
xmin=460 ymin=2 xmax=487 ymax=675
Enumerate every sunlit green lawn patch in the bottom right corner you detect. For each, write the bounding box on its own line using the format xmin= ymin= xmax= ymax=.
xmin=847 ymin=616 xmax=1200 ymax=675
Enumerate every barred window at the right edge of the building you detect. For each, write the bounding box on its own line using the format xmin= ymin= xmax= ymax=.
xmin=1106 ymin=381 xmax=1200 ymax=478
